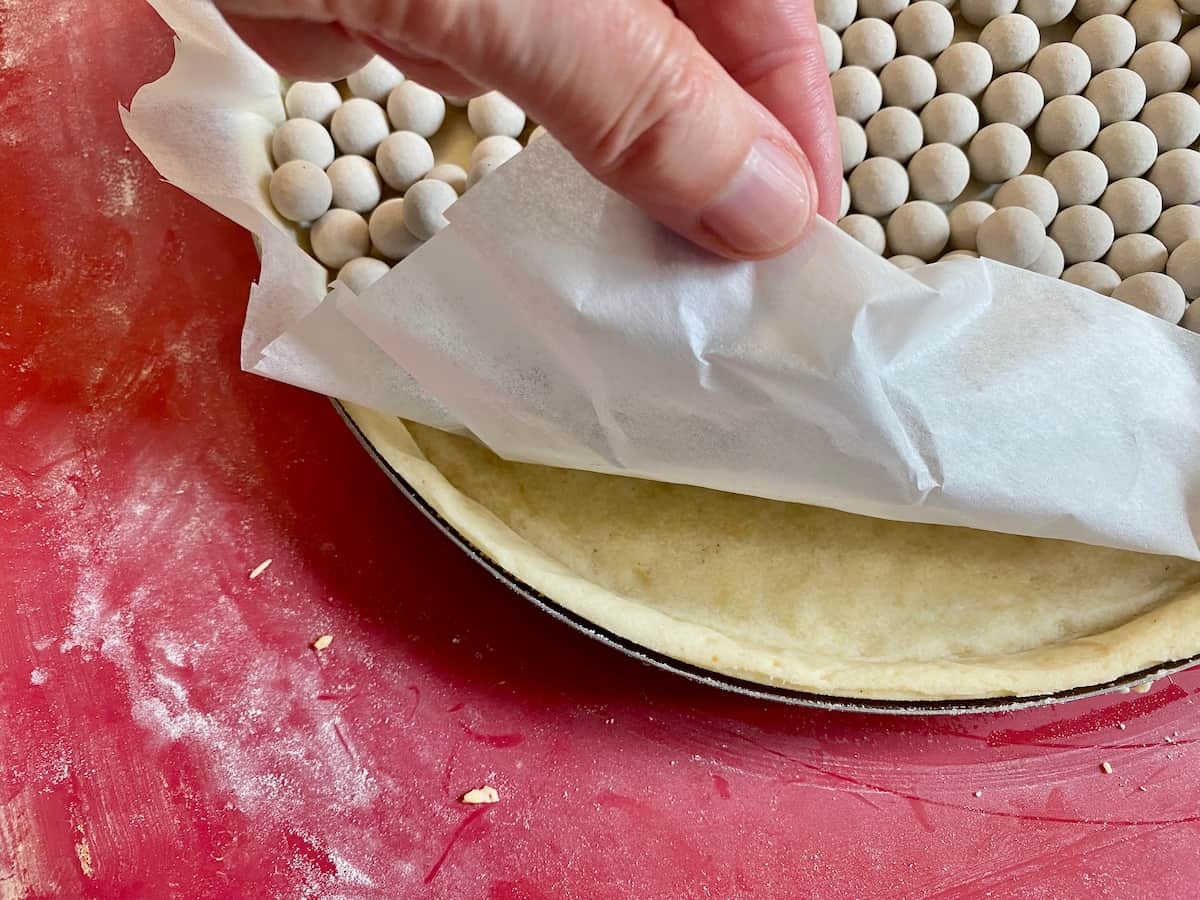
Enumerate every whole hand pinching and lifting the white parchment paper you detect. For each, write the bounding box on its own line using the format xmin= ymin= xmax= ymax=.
xmin=216 ymin=0 xmax=841 ymax=259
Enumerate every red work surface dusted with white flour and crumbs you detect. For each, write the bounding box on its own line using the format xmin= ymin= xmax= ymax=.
xmin=0 ymin=0 xmax=1200 ymax=899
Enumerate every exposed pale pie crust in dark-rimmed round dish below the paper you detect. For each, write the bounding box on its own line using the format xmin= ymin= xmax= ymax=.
xmin=344 ymin=404 xmax=1200 ymax=712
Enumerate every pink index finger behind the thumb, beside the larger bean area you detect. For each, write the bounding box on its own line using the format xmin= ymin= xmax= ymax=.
xmin=676 ymin=0 xmax=842 ymax=218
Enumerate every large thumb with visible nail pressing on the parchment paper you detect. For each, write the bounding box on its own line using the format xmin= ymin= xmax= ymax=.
xmin=222 ymin=0 xmax=817 ymax=258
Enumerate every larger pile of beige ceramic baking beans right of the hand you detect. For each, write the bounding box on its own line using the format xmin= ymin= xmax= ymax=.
xmin=815 ymin=0 xmax=1200 ymax=331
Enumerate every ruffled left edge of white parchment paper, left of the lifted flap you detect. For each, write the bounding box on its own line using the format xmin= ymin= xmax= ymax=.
xmin=122 ymin=0 xmax=462 ymax=431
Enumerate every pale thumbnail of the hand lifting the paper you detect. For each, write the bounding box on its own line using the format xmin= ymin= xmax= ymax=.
xmin=700 ymin=138 xmax=816 ymax=257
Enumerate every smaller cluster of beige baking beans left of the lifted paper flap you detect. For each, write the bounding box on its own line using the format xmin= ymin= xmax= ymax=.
xmin=269 ymin=58 xmax=541 ymax=293
